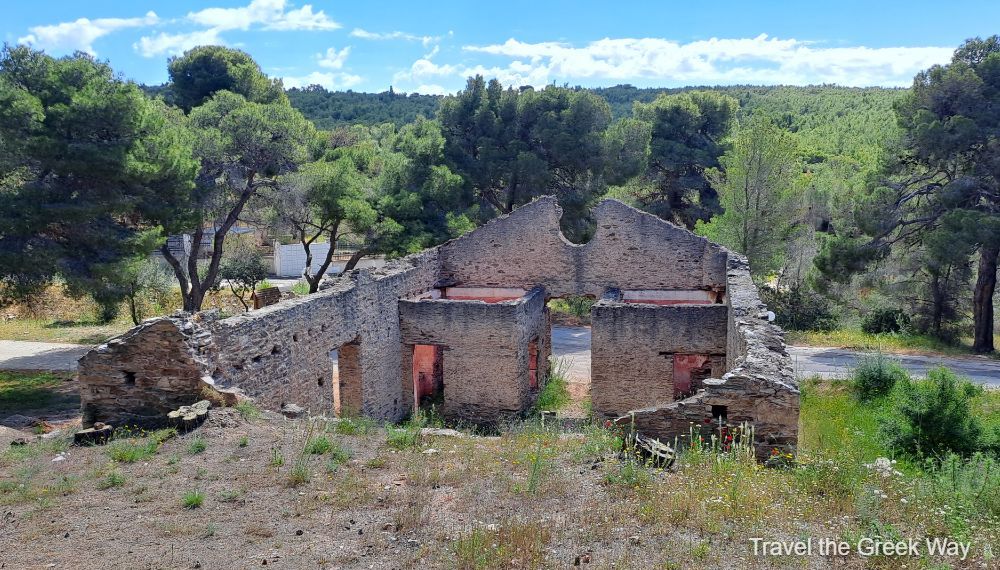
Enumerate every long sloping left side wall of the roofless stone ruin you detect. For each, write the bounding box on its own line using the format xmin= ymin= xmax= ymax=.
xmin=80 ymin=250 xmax=438 ymax=423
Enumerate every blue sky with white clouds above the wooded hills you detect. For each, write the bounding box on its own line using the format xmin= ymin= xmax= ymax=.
xmin=0 ymin=0 xmax=1000 ymax=93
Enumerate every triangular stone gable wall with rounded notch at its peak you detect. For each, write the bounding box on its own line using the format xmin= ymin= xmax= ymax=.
xmin=441 ymin=197 xmax=726 ymax=298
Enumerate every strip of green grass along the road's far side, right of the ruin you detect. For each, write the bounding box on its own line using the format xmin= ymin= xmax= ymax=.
xmin=785 ymin=328 xmax=1000 ymax=358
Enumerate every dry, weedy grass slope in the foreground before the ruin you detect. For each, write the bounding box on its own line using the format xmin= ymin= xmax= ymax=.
xmin=0 ymin=383 xmax=1000 ymax=569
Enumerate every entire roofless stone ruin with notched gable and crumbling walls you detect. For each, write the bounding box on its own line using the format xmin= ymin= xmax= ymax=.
xmin=79 ymin=197 xmax=799 ymax=455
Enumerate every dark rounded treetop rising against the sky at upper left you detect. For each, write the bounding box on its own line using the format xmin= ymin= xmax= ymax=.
xmin=166 ymin=46 xmax=287 ymax=112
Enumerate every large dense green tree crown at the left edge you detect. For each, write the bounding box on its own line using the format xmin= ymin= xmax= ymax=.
xmin=0 ymin=47 xmax=198 ymax=308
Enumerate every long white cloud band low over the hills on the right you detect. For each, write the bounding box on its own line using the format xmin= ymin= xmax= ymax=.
xmin=454 ymin=34 xmax=953 ymax=86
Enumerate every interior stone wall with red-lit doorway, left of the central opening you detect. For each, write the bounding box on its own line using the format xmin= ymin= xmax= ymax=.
xmin=399 ymin=290 xmax=546 ymax=423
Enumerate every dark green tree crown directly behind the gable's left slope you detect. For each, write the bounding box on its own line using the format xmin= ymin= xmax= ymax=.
xmin=438 ymin=76 xmax=612 ymax=241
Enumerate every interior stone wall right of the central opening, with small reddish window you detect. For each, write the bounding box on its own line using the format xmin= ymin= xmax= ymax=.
xmin=590 ymin=299 xmax=729 ymax=417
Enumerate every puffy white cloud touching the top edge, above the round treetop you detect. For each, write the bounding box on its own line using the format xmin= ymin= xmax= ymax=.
xmin=187 ymin=0 xmax=340 ymax=31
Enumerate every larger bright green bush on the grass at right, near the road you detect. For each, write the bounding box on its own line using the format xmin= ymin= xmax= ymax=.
xmin=882 ymin=367 xmax=988 ymax=457
